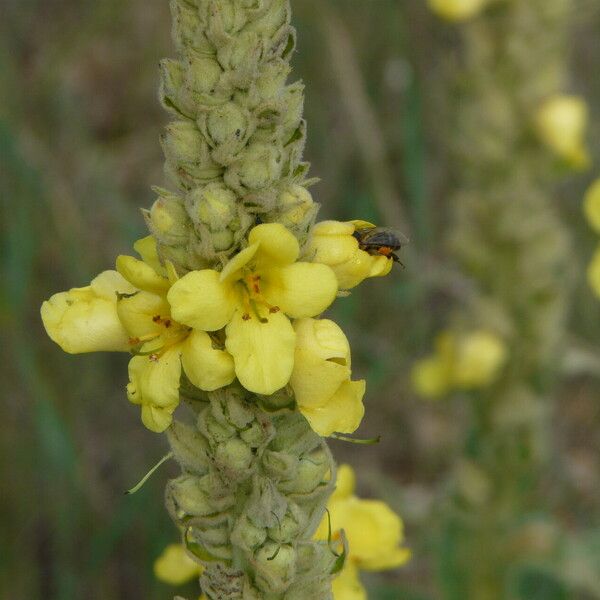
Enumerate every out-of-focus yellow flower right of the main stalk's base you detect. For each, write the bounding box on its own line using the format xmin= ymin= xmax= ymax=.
xmin=315 ymin=465 xmax=411 ymax=600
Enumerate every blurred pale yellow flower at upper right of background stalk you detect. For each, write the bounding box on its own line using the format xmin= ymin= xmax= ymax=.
xmin=535 ymin=94 xmax=590 ymax=169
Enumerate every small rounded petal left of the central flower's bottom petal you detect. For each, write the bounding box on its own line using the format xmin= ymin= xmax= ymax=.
xmin=181 ymin=330 xmax=235 ymax=392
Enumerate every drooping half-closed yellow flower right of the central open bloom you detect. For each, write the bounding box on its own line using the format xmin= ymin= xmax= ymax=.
xmin=290 ymin=318 xmax=365 ymax=436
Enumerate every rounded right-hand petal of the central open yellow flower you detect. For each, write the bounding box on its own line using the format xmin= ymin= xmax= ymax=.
xmin=261 ymin=262 xmax=337 ymax=319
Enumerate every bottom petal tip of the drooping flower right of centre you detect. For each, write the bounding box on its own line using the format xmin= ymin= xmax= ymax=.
xmin=298 ymin=380 xmax=366 ymax=437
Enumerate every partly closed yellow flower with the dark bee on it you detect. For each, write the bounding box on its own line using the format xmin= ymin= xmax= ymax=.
xmin=307 ymin=221 xmax=393 ymax=290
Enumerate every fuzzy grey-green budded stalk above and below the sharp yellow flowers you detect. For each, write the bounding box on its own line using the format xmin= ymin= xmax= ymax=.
xmin=152 ymin=0 xmax=336 ymax=600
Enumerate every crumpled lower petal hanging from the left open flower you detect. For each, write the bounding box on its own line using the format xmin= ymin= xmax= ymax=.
xmin=127 ymin=346 xmax=181 ymax=433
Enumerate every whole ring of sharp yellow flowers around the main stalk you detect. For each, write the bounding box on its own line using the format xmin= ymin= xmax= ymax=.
xmin=41 ymin=221 xmax=392 ymax=436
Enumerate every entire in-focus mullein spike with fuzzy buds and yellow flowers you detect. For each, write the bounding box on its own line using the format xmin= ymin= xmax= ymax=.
xmin=41 ymin=0 xmax=408 ymax=600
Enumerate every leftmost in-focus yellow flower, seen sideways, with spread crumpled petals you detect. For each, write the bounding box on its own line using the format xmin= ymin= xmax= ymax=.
xmin=41 ymin=237 xmax=235 ymax=432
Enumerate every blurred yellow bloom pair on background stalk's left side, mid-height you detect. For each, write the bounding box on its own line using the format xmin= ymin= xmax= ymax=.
xmin=412 ymin=329 xmax=507 ymax=398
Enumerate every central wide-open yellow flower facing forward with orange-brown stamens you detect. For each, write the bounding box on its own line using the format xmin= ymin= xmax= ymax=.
xmin=168 ymin=223 xmax=337 ymax=394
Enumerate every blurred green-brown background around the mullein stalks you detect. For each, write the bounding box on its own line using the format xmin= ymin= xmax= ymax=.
xmin=0 ymin=0 xmax=600 ymax=600
